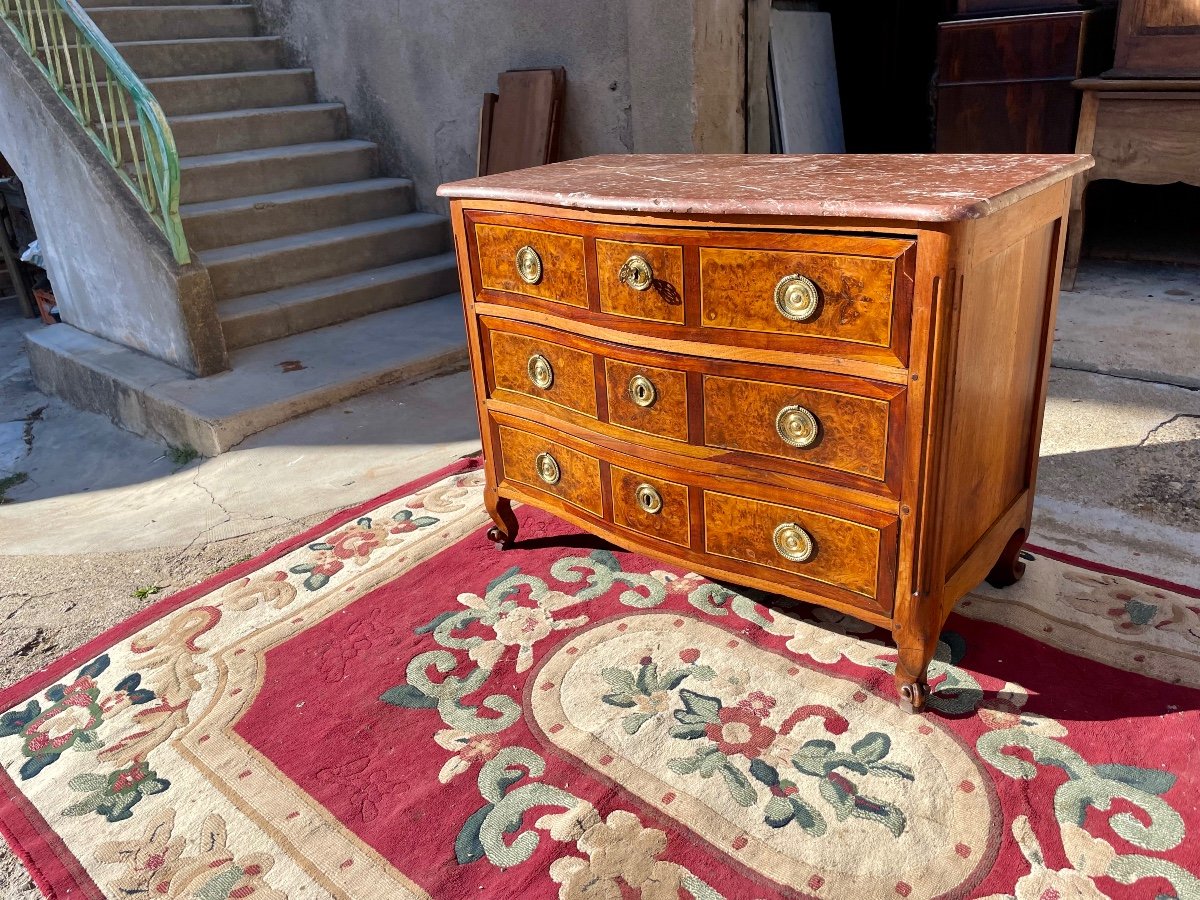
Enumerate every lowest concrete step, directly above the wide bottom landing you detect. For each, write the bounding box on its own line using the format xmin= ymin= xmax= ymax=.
xmin=218 ymin=253 xmax=458 ymax=350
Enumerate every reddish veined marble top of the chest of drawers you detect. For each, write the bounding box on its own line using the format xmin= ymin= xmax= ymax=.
xmin=438 ymin=154 xmax=1092 ymax=222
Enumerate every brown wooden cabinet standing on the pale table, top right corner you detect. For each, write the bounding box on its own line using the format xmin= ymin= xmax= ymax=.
xmin=1105 ymin=0 xmax=1200 ymax=78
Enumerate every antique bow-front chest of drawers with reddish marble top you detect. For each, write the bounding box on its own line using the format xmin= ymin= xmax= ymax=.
xmin=440 ymin=156 xmax=1091 ymax=708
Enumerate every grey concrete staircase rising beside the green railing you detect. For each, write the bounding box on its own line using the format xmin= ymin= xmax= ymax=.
xmin=27 ymin=0 xmax=466 ymax=454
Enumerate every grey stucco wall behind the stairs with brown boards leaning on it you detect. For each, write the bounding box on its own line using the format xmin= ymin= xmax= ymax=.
xmin=256 ymin=0 xmax=744 ymax=209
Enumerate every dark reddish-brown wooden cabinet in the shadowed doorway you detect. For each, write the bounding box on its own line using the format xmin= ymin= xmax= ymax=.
xmin=936 ymin=10 xmax=1114 ymax=154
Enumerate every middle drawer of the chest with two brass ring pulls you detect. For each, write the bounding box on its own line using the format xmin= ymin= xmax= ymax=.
xmin=481 ymin=318 xmax=905 ymax=497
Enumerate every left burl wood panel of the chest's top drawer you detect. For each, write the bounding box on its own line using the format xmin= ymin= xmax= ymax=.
xmin=475 ymin=224 xmax=588 ymax=306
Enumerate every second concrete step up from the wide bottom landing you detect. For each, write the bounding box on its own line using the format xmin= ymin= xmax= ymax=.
xmin=197 ymin=212 xmax=450 ymax=300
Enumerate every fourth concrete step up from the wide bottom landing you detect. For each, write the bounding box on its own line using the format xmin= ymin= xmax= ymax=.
xmin=179 ymin=140 xmax=378 ymax=203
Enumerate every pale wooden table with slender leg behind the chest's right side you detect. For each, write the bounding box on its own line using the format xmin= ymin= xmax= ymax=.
xmin=1062 ymin=78 xmax=1200 ymax=289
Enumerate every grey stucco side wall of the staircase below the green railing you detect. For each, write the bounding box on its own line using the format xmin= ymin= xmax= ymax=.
xmin=0 ymin=26 xmax=227 ymax=374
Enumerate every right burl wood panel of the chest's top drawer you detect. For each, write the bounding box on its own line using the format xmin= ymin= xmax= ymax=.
xmin=700 ymin=247 xmax=895 ymax=347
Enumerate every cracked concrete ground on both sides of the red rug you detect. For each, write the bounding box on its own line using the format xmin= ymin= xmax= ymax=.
xmin=0 ymin=263 xmax=1200 ymax=900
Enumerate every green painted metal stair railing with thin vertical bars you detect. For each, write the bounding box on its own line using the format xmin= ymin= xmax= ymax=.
xmin=0 ymin=0 xmax=191 ymax=264
